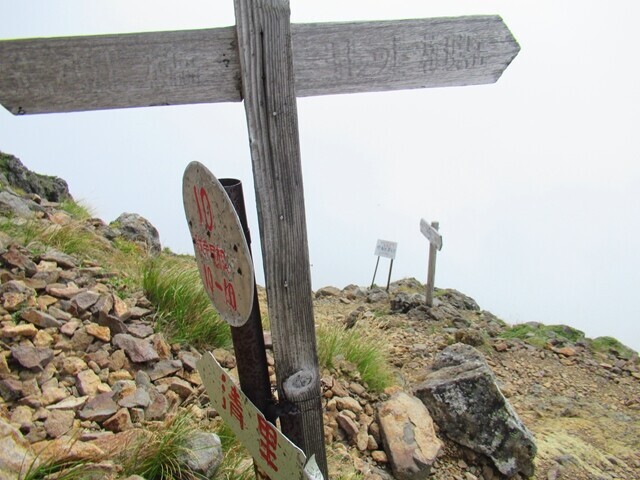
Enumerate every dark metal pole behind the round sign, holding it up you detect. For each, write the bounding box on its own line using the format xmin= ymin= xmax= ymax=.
xmin=220 ymin=178 xmax=276 ymax=423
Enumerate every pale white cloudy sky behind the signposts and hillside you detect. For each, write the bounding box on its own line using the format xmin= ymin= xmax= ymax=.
xmin=0 ymin=0 xmax=640 ymax=349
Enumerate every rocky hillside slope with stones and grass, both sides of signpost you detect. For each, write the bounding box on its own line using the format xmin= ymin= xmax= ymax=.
xmin=0 ymin=153 xmax=640 ymax=480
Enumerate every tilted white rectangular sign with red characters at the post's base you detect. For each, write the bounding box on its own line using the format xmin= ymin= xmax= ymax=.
xmin=196 ymin=352 xmax=322 ymax=480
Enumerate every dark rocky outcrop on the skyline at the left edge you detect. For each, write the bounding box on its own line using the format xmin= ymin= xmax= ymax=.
xmin=0 ymin=152 xmax=71 ymax=202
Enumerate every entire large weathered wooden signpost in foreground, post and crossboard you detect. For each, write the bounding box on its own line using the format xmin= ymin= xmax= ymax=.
xmin=0 ymin=0 xmax=519 ymax=478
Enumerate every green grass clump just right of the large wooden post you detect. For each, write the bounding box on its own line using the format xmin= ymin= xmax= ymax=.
xmin=317 ymin=325 xmax=393 ymax=392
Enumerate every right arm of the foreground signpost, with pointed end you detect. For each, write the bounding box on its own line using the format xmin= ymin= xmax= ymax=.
xmin=293 ymin=15 xmax=520 ymax=96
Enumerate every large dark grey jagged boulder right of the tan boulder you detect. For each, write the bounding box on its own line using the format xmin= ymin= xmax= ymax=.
xmin=415 ymin=343 xmax=537 ymax=477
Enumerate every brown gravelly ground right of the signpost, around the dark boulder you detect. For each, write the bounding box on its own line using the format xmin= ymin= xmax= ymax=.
xmin=316 ymin=280 xmax=640 ymax=480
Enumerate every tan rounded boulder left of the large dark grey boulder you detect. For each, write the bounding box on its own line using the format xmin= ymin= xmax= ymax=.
xmin=378 ymin=392 xmax=442 ymax=480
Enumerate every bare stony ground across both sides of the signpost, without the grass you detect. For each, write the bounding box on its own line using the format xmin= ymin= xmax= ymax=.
xmin=0 ymin=154 xmax=640 ymax=480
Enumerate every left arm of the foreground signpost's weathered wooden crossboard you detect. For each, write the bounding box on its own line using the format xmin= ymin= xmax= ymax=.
xmin=0 ymin=27 xmax=241 ymax=114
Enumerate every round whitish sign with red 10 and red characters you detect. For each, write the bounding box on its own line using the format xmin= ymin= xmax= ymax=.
xmin=182 ymin=162 xmax=254 ymax=327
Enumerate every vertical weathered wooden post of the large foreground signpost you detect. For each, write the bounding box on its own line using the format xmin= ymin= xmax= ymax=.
xmin=235 ymin=0 xmax=329 ymax=478
